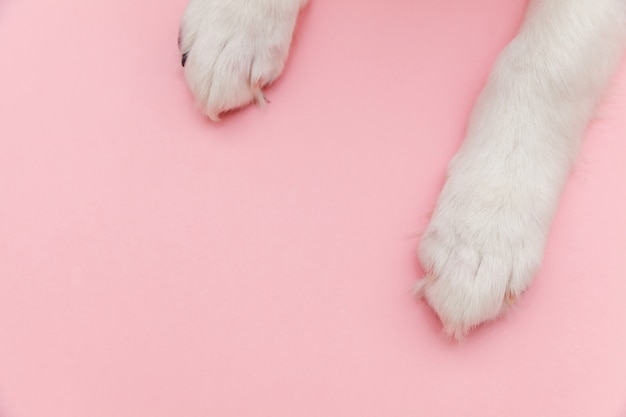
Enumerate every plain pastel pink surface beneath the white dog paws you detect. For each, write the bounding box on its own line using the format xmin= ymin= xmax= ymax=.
xmin=0 ymin=0 xmax=626 ymax=417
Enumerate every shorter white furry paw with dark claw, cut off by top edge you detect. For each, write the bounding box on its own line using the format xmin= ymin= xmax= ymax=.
xmin=179 ymin=0 xmax=304 ymax=121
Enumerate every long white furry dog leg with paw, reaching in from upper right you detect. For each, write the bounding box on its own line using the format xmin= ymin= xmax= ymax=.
xmin=416 ymin=0 xmax=626 ymax=338
